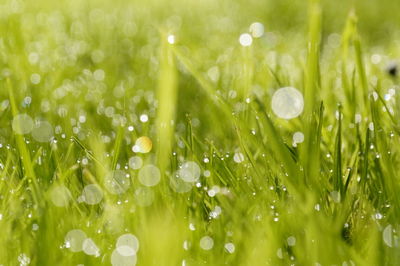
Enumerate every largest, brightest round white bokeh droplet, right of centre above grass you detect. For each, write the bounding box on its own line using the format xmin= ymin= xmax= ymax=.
xmin=271 ymin=87 xmax=304 ymax=120
